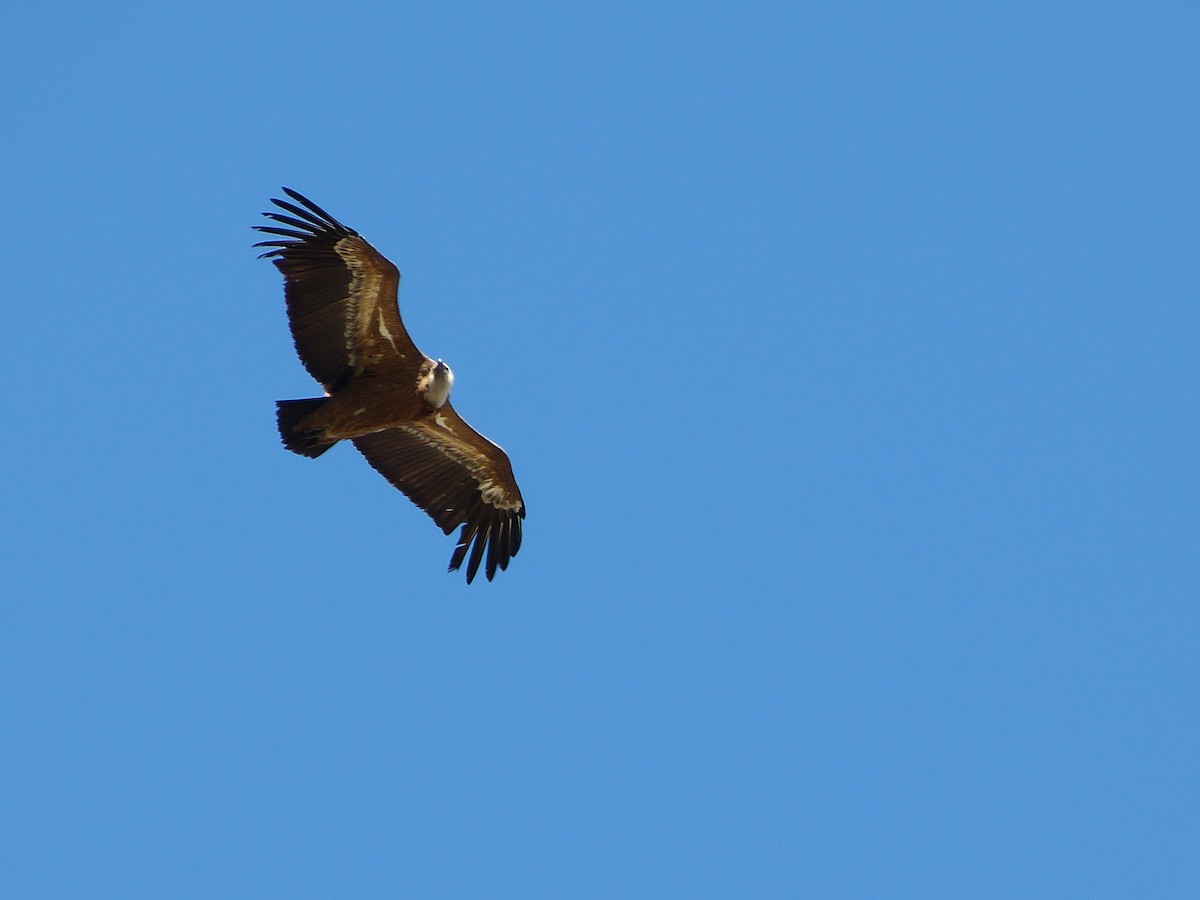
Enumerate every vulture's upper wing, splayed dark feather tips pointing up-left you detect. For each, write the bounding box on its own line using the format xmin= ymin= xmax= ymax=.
xmin=254 ymin=187 xmax=424 ymax=391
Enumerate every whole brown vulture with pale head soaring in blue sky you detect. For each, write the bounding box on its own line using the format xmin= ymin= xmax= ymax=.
xmin=254 ymin=187 xmax=524 ymax=584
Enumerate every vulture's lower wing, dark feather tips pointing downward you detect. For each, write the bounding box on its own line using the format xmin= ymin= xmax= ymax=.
xmin=354 ymin=403 xmax=524 ymax=584
